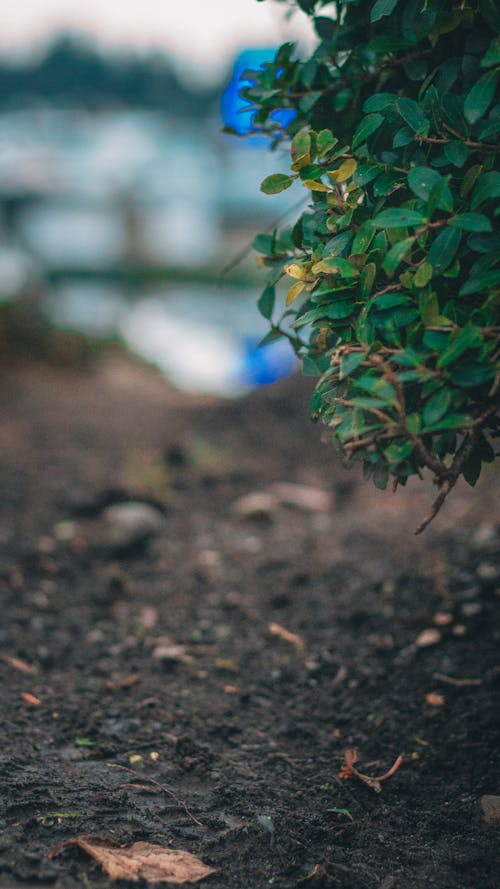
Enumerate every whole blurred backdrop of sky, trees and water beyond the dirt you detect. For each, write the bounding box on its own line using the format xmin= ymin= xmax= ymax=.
xmin=0 ymin=0 xmax=311 ymax=395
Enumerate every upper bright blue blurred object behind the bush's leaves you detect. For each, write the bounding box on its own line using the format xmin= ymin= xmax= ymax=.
xmin=221 ymin=47 xmax=296 ymax=136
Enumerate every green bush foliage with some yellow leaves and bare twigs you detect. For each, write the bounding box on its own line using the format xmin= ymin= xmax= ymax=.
xmin=242 ymin=0 xmax=500 ymax=527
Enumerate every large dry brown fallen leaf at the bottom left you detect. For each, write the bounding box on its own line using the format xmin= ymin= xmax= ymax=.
xmin=48 ymin=835 xmax=215 ymax=884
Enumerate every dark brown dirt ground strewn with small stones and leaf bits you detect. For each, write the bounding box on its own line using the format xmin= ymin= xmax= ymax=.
xmin=0 ymin=352 xmax=500 ymax=889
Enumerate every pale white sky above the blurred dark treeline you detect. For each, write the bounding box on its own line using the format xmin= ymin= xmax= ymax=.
xmin=0 ymin=0 xmax=309 ymax=82
